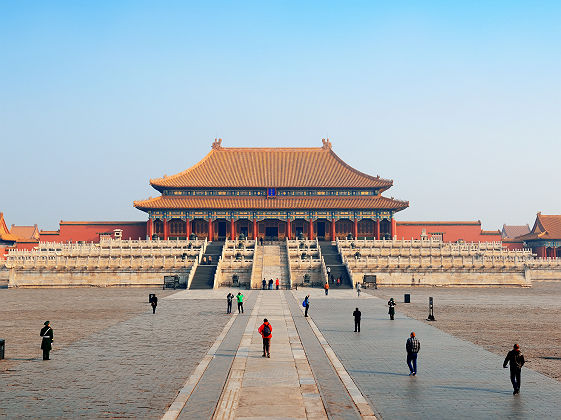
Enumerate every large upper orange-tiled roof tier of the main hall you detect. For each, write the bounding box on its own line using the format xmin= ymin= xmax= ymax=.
xmin=150 ymin=139 xmax=393 ymax=191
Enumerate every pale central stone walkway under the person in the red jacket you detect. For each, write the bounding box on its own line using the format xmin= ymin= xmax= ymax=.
xmin=213 ymin=291 xmax=327 ymax=420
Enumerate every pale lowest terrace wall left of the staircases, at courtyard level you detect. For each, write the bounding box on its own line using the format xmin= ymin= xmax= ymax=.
xmin=8 ymin=269 xmax=189 ymax=287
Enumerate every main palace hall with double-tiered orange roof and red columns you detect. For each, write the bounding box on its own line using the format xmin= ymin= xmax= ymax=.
xmin=134 ymin=139 xmax=409 ymax=240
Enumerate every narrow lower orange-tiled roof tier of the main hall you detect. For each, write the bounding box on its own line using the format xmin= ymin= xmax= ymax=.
xmin=134 ymin=196 xmax=409 ymax=211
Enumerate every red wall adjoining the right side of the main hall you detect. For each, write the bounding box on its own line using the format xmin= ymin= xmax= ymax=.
xmin=397 ymin=222 xmax=502 ymax=242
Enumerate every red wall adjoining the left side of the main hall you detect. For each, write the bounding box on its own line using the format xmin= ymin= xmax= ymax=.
xmin=40 ymin=221 xmax=146 ymax=242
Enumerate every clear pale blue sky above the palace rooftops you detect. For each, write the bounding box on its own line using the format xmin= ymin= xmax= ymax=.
xmin=0 ymin=0 xmax=561 ymax=229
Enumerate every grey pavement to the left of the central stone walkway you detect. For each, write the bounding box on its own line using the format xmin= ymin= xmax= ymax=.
xmin=0 ymin=293 xmax=236 ymax=419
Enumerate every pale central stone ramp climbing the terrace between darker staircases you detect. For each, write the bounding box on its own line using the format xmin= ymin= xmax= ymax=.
xmin=251 ymin=243 xmax=290 ymax=289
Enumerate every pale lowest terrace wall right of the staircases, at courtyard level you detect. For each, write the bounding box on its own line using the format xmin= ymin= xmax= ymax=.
xmin=353 ymin=270 xmax=532 ymax=287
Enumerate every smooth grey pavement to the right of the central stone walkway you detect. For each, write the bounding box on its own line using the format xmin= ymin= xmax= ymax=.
xmin=295 ymin=289 xmax=561 ymax=419
